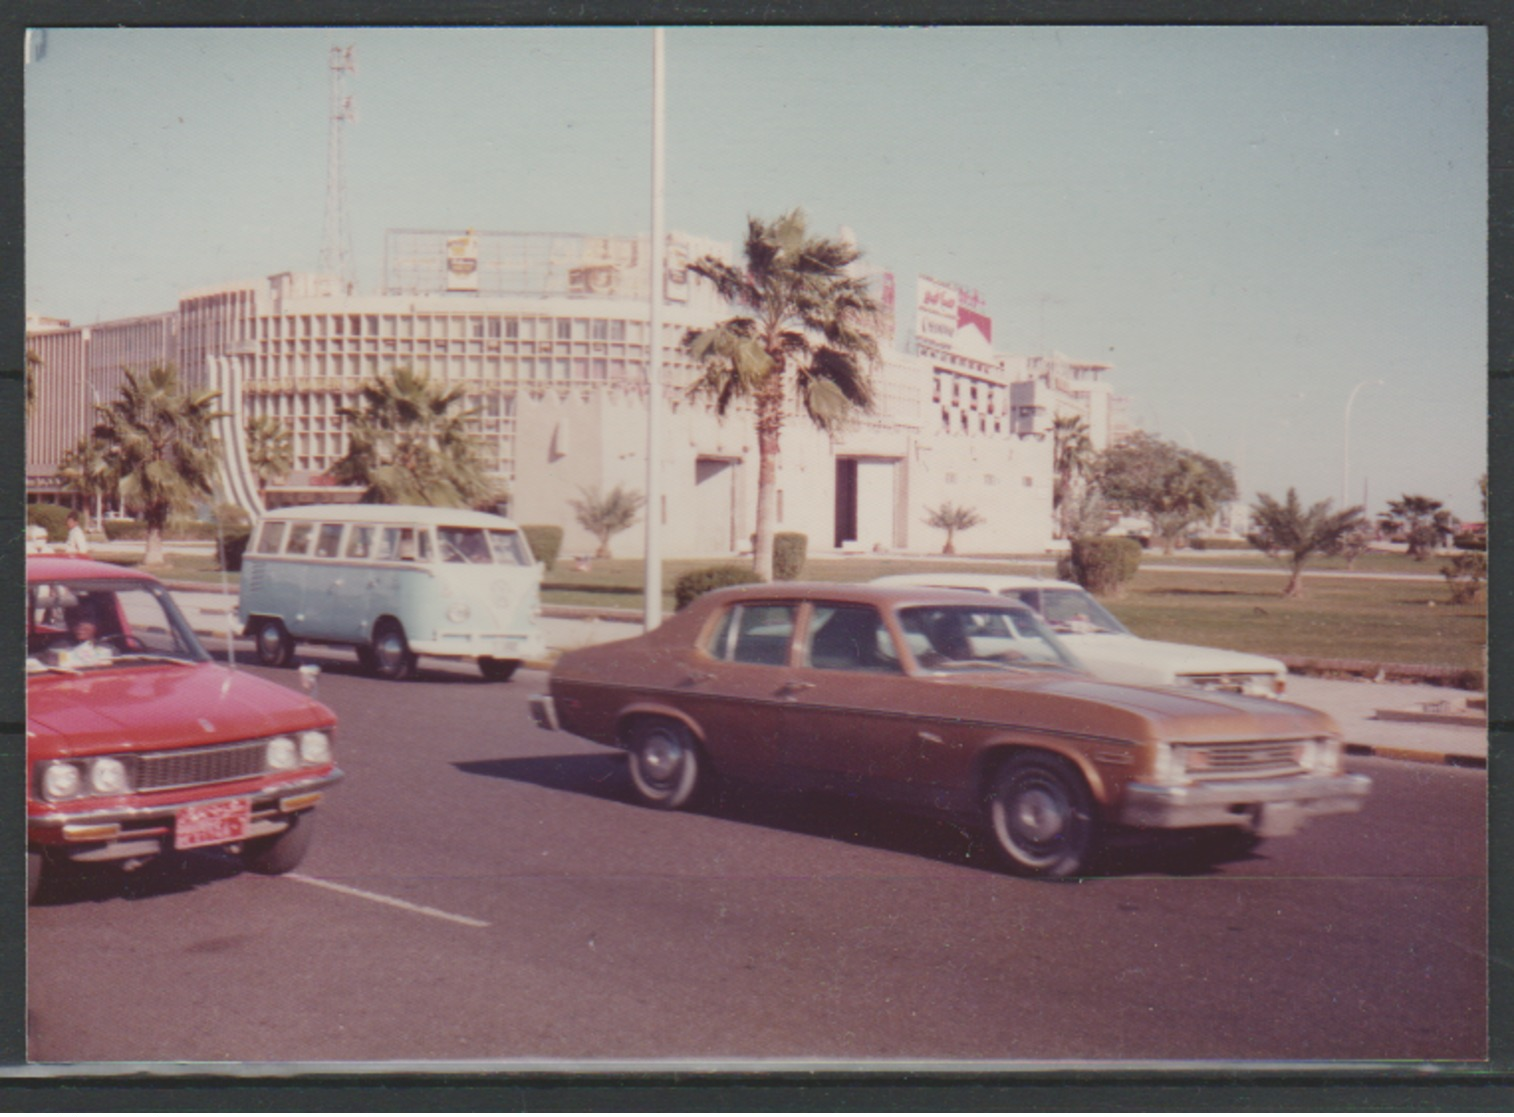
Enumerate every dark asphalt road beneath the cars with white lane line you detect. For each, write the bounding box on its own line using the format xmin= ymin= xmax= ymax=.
xmin=29 ymin=652 xmax=1487 ymax=1066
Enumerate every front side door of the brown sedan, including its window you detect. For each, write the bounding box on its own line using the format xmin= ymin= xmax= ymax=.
xmin=783 ymin=601 xmax=921 ymax=799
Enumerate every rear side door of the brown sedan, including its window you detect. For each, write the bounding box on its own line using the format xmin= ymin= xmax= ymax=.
xmin=668 ymin=601 xmax=799 ymax=783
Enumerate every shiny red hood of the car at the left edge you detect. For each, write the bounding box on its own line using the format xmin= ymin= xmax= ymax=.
xmin=26 ymin=663 xmax=336 ymax=755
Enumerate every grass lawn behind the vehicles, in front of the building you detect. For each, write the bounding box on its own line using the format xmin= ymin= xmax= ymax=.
xmin=98 ymin=552 xmax=1487 ymax=667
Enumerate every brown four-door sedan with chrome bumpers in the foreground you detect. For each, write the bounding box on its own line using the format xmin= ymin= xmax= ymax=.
xmin=531 ymin=583 xmax=1370 ymax=876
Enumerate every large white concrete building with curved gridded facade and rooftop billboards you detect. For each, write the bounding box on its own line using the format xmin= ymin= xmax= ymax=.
xmin=27 ymin=230 xmax=1123 ymax=557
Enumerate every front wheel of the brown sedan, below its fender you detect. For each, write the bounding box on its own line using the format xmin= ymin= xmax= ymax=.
xmin=987 ymin=752 xmax=1099 ymax=879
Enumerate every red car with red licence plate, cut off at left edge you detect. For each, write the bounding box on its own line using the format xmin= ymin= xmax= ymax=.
xmin=26 ymin=557 xmax=342 ymax=898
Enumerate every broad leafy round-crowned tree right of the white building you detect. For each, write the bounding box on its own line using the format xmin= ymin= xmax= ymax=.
xmin=1093 ymin=431 xmax=1235 ymax=554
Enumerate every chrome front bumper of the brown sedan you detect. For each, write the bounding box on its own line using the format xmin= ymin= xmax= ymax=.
xmin=1117 ymin=775 xmax=1372 ymax=837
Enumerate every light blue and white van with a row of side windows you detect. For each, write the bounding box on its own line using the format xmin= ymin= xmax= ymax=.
xmin=236 ymin=504 xmax=545 ymax=683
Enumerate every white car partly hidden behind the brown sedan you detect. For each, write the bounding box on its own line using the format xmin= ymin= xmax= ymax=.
xmin=874 ymin=572 xmax=1288 ymax=698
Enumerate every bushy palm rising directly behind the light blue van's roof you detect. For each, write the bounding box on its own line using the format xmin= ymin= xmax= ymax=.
xmin=332 ymin=365 xmax=501 ymax=509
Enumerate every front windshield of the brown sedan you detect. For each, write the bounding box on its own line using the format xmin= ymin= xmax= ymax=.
xmin=899 ymin=605 xmax=1081 ymax=671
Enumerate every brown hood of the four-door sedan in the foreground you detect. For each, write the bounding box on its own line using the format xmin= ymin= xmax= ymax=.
xmin=939 ymin=672 xmax=1340 ymax=743
